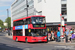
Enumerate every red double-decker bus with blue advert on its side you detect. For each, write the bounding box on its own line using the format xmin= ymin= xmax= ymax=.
xmin=13 ymin=15 xmax=47 ymax=43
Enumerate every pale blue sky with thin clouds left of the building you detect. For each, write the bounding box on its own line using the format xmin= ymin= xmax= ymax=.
xmin=0 ymin=0 xmax=15 ymax=22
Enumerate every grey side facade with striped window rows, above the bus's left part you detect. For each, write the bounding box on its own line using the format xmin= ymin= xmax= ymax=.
xmin=11 ymin=0 xmax=34 ymax=26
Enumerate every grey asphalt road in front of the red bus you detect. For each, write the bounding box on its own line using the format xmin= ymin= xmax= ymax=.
xmin=0 ymin=32 xmax=75 ymax=50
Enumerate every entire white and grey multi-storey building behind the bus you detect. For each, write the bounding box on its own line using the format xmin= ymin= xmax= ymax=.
xmin=11 ymin=0 xmax=75 ymax=31
